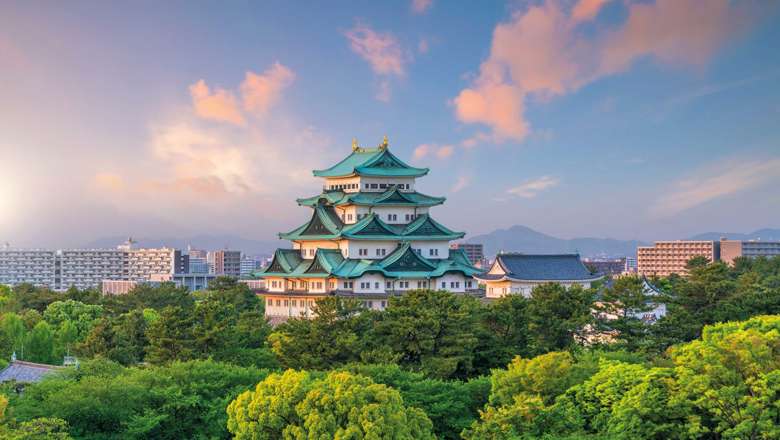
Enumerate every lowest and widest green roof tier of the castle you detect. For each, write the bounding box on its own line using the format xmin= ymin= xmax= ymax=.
xmin=257 ymin=242 xmax=480 ymax=278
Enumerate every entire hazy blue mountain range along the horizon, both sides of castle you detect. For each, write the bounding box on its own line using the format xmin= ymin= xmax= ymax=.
xmin=85 ymin=229 xmax=780 ymax=257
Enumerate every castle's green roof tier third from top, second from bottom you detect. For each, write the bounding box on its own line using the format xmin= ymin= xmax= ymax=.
xmin=279 ymin=204 xmax=465 ymax=241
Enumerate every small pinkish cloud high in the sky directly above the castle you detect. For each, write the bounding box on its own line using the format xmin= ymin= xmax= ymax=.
xmin=344 ymin=23 xmax=409 ymax=102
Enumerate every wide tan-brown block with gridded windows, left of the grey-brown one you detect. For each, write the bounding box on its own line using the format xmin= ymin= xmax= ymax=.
xmin=636 ymin=240 xmax=720 ymax=276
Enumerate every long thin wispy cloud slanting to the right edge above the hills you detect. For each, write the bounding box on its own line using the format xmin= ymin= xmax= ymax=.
xmin=649 ymin=159 xmax=780 ymax=218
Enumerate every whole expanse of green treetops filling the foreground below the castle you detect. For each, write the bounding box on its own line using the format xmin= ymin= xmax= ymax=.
xmin=0 ymin=258 xmax=780 ymax=439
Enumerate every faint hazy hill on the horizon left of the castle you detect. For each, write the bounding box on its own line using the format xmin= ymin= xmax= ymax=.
xmin=84 ymin=235 xmax=280 ymax=255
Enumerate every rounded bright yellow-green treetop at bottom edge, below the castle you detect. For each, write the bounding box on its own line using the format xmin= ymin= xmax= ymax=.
xmin=227 ymin=370 xmax=434 ymax=440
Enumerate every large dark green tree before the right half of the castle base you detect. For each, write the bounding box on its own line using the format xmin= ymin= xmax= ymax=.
xmin=368 ymin=290 xmax=480 ymax=378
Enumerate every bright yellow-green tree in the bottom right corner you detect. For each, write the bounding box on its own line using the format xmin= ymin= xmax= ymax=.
xmin=672 ymin=316 xmax=780 ymax=438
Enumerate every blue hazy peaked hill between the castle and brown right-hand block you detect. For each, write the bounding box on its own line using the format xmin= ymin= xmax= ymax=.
xmin=466 ymin=225 xmax=647 ymax=257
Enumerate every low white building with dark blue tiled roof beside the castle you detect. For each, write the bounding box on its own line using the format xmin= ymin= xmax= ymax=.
xmin=474 ymin=253 xmax=604 ymax=298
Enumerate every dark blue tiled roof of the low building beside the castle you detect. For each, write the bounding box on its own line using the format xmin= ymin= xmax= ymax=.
xmin=475 ymin=253 xmax=602 ymax=282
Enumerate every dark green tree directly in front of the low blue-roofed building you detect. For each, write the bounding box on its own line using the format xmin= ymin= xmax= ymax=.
xmin=527 ymin=283 xmax=593 ymax=354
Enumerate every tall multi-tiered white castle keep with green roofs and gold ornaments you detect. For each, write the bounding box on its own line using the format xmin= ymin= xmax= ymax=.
xmin=258 ymin=138 xmax=478 ymax=316
